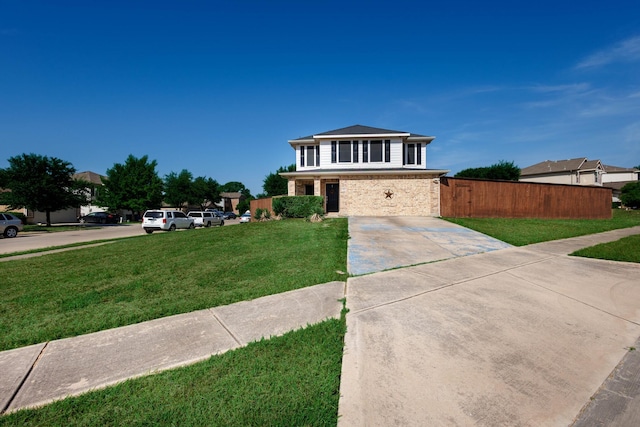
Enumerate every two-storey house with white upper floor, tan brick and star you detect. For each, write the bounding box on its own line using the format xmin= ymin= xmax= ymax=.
xmin=280 ymin=125 xmax=449 ymax=216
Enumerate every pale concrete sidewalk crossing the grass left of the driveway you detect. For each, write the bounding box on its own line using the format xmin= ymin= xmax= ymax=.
xmin=0 ymin=282 xmax=345 ymax=411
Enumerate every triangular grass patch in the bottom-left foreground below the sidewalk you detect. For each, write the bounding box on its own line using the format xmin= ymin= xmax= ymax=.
xmin=0 ymin=316 xmax=345 ymax=426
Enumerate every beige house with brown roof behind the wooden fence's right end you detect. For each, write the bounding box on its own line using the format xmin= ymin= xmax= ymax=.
xmin=520 ymin=157 xmax=607 ymax=186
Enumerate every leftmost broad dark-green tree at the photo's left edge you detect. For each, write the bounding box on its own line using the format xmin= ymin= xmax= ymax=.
xmin=0 ymin=154 xmax=88 ymax=226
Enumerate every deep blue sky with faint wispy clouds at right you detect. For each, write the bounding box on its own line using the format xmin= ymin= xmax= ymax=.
xmin=0 ymin=0 xmax=640 ymax=195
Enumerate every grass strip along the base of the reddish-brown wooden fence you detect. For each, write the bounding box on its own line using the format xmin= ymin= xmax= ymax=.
xmin=444 ymin=209 xmax=640 ymax=246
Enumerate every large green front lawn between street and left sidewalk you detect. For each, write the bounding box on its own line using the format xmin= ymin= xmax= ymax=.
xmin=0 ymin=218 xmax=348 ymax=351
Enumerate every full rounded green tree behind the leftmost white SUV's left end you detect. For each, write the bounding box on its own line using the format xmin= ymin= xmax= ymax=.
xmin=98 ymin=154 xmax=162 ymax=214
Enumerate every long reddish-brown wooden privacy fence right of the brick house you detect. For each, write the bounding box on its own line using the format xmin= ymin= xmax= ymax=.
xmin=440 ymin=177 xmax=611 ymax=219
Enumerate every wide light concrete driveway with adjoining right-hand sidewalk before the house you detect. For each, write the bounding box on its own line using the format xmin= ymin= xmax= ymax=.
xmin=339 ymin=218 xmax=640 ymax=426
